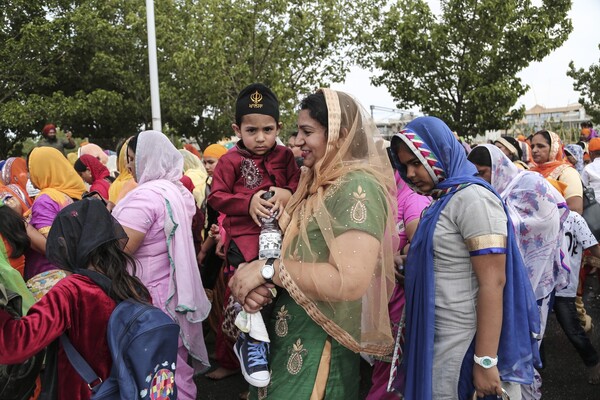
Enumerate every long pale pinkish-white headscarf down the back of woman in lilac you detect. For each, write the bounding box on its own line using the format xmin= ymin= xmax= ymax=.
xmin=135 ymin=131 xmax=211 ymax=366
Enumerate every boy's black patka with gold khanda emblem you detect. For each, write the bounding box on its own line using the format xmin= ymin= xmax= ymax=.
xmin=235 ymin=83 xmax=279 ymax=125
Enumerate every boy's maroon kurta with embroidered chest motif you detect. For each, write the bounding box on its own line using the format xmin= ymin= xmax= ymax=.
xmin=208 ymin=140 xmax=300 ymax=261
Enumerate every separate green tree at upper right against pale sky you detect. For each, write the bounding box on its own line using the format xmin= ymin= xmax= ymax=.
xmin=361 ymin=0 xmax=572 ymax=135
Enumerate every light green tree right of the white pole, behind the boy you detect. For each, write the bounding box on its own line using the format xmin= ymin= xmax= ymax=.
xmin=157 ymin=0 xmax=384 ymax=147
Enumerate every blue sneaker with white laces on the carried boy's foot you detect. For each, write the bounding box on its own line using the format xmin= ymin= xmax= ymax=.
xmin=233 ymin=333 xmax=271 ymax=387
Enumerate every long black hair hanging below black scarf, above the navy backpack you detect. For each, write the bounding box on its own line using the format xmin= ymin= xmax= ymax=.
xmin=85 ymin=239 xmax=150 ymax=302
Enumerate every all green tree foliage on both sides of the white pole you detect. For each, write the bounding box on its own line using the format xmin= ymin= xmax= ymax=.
xmin=0 ymin=0 xmax=383 ymax=158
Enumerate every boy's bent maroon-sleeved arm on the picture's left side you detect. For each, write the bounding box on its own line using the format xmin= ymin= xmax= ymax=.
xmin=207 ymin=157 xmax=254 ymax=215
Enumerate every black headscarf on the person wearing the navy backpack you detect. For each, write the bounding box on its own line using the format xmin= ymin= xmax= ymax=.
xmin=46 ymin=198 xmax=127 ymax=271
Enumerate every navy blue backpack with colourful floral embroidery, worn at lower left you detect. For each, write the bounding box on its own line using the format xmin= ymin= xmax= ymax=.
xmin=60 ymin=271 xmax=179 ymax=400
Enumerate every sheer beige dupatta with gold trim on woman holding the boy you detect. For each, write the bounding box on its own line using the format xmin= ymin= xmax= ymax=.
xmin=279 ymin=89 xmax=397 ymax=355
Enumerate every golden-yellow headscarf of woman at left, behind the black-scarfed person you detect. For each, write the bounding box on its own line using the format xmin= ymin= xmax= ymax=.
xmin=29 ymin=147 xmax=86 ymax=206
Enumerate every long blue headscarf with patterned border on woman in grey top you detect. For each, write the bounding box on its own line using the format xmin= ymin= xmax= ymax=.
xmin=392 ymin=117 xmax=540 ymax=399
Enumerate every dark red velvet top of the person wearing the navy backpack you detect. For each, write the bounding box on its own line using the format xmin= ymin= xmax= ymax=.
xmin=0 ymin=275 xmax=116 ymax=400
